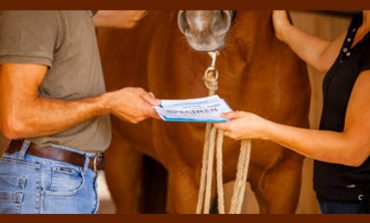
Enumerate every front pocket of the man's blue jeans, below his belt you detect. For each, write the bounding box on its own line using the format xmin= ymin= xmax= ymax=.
xmin=46 ymin=166 xmax=85 ymax=196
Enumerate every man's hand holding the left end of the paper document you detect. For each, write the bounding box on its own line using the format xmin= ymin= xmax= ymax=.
xmin=106 ymin=87 xmax=160 ymax=123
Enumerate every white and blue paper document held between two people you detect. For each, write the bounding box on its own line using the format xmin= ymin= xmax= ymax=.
xmin=154 ymin=95 xmax=232 ymax=122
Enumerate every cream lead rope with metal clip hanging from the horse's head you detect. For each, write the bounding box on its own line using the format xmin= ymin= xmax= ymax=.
xmin=196 ymin=51 xmax=251 ymax=214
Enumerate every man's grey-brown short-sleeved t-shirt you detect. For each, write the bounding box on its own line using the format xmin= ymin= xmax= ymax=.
xmin=0 ymin=11 xmax=111 ymax=151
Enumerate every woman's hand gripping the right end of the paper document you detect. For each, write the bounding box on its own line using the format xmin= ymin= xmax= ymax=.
xmin=215 ymin=111 xmax=271 ymax=140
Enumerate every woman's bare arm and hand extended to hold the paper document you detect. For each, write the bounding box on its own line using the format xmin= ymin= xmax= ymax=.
xmin=216 ymin=71 xmax=370 ymax=166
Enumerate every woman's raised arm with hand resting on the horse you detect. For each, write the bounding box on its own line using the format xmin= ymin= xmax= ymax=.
xmin=273 ymin=10 xmax=345 ymax=72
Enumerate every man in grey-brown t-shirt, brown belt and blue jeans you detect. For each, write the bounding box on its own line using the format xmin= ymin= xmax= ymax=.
xmin=0 ymin=11 xmax=158 ymax=214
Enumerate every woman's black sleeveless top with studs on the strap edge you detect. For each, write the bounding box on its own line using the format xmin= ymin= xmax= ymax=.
xmin=314 ymin=14 xmax=370 ymax=201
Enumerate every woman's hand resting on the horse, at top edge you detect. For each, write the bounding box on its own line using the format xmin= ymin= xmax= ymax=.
xmin=272 ymin=10 xmax=292 ymax=41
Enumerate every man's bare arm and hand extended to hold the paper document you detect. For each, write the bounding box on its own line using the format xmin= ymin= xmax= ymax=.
xmin=0 ymin=64 xmax=158 ymax=142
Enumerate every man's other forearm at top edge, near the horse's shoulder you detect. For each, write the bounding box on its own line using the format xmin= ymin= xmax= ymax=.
xmin=93 ymin=10 xmax=147 ymax=29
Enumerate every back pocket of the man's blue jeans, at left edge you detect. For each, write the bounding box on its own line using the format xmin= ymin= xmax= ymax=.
xmin=0 ymin=175 xmax=26 ymax=214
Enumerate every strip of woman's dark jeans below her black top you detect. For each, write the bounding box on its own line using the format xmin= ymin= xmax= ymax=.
xmin=319 ymin=200 xmax=370 ymax=214
